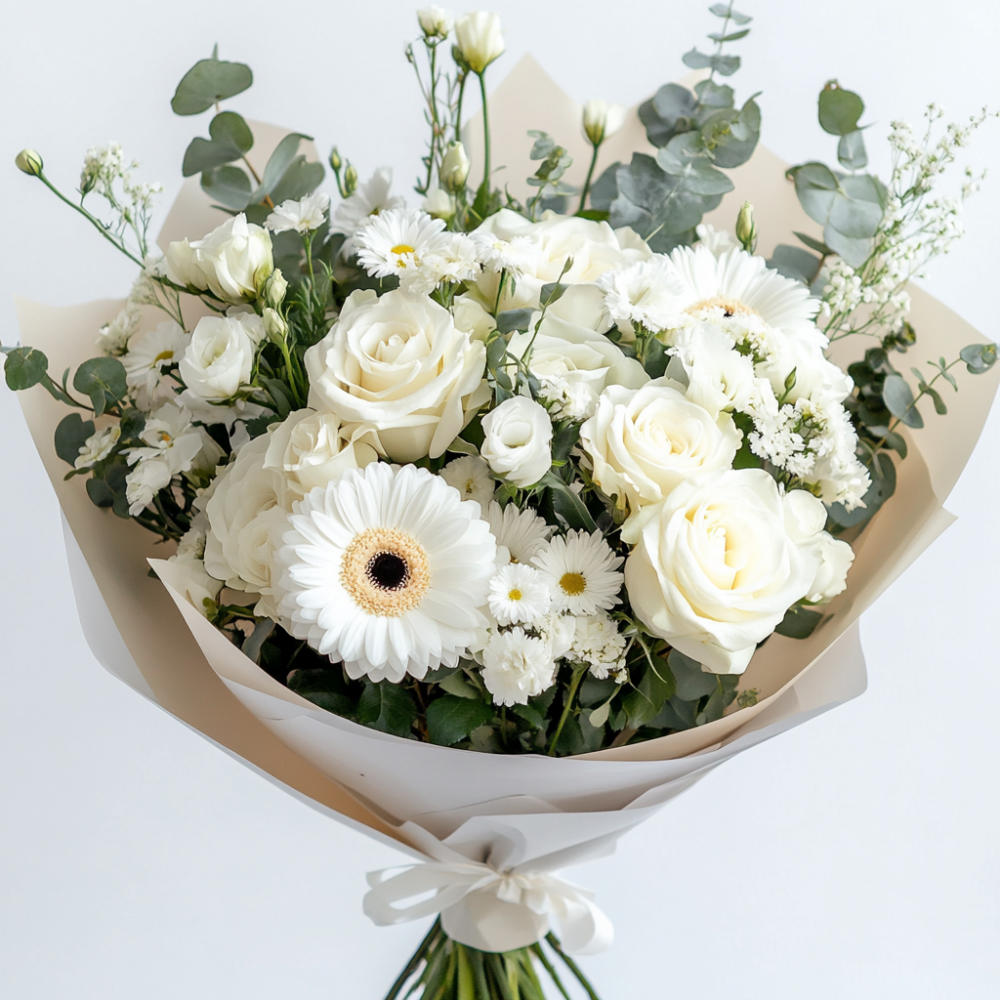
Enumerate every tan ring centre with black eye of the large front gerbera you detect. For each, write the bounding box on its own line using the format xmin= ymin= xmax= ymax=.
xmin=340 ymin=528 xmax=431 ymax=618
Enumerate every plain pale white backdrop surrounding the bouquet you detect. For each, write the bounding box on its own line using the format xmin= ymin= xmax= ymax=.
xmin=0 ymin=0 xmax=1000 ymax=1000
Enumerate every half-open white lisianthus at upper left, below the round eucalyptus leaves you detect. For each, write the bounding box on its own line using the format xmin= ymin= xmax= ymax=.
xmin=166 ymin=212 xmax=274 ymax=304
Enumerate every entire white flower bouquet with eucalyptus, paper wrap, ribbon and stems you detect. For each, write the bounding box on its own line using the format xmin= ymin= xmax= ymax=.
xmin=4 ymin=5 xmax=996 ymax=998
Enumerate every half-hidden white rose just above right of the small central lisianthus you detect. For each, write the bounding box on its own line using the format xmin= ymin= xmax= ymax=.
xmin=507 ymin=313 xmax=649 ymax=419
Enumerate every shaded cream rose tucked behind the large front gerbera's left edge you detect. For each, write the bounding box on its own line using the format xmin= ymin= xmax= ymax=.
xmin=198 ymin=428 xmax=296 ymax=618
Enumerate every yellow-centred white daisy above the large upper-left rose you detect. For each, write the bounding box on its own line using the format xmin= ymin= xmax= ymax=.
xmin=354 ymin=208 xmax=449 ymax=287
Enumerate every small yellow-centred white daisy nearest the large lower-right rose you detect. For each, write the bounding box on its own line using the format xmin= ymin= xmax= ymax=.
xmin=531 ymin=531 xmax=625 ymax=615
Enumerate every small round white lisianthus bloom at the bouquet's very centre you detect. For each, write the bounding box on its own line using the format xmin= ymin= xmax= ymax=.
xmin=480 ymin=396 xmax=552 ymax=489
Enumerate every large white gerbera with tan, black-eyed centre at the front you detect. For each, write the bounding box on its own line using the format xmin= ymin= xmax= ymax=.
xmin=278 ymin=462 xmax=496 ymax=683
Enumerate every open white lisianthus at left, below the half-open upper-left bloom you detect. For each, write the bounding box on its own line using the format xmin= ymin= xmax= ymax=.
xmin=178 ymin=313 xmax=266 ymax=400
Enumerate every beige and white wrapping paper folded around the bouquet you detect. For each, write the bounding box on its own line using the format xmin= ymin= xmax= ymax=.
xmin=11 ymin=57 xmax=1000 ymax=856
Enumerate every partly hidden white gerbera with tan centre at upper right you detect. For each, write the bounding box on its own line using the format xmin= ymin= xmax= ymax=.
xmin=670 ymin=246 xmax=819 ymax=339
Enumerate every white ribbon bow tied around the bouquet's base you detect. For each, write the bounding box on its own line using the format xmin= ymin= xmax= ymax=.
xmin=364 ymin=859 xmax=614 ymax=955
